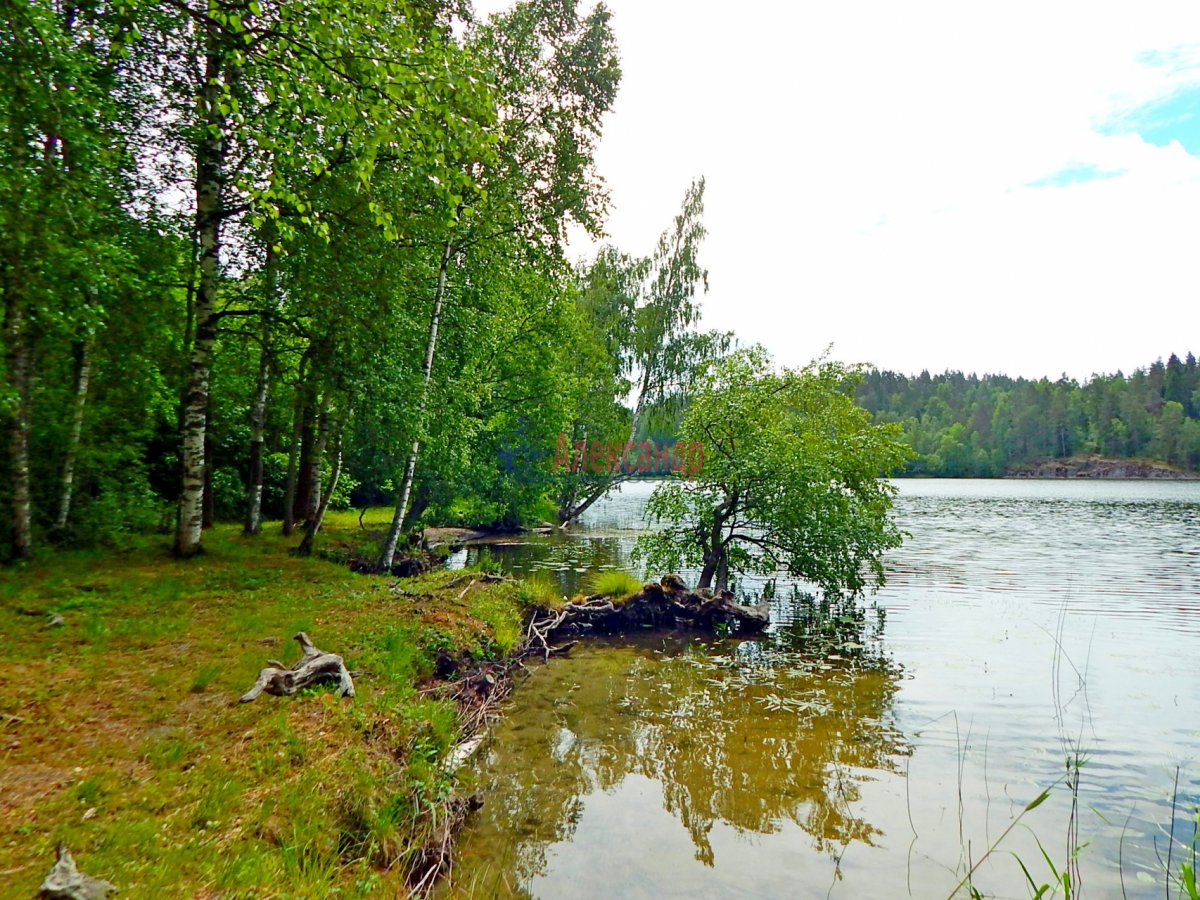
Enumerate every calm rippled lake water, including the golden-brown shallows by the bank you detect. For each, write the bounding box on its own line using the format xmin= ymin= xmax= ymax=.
xmin=443 ymin=480 xmax=1200 ymax=898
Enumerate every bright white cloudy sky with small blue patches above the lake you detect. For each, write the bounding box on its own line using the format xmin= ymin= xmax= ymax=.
xmin=476 ymin=0 xmax=1200 ymax=380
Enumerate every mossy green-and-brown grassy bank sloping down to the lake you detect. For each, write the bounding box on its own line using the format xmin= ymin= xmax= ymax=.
xmin=0 ymin=514 xmax=521 ymax=898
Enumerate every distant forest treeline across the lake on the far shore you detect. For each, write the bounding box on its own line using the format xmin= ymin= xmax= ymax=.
xmin=858 ymin=353 xmax=1200 ymax=478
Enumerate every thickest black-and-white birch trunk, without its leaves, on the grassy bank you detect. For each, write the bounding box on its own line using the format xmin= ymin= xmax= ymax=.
xmin=175 ymin=30 xmax=226 ymax=558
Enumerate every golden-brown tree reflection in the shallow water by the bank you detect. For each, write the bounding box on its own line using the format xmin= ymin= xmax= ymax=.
xmin=444 ymin=598 xmax=908 ymax=896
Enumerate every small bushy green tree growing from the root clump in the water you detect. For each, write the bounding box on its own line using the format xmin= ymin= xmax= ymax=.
xmin=636 ymin=349 xmax=911 ymax=594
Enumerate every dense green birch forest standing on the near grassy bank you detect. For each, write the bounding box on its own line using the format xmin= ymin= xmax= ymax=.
xmin=0 ymin=0 xmax=744 ymax=564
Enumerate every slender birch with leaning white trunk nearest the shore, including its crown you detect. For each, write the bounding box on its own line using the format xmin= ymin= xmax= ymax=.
xmin=378 ymin=0 xmax=620 ymax=570
